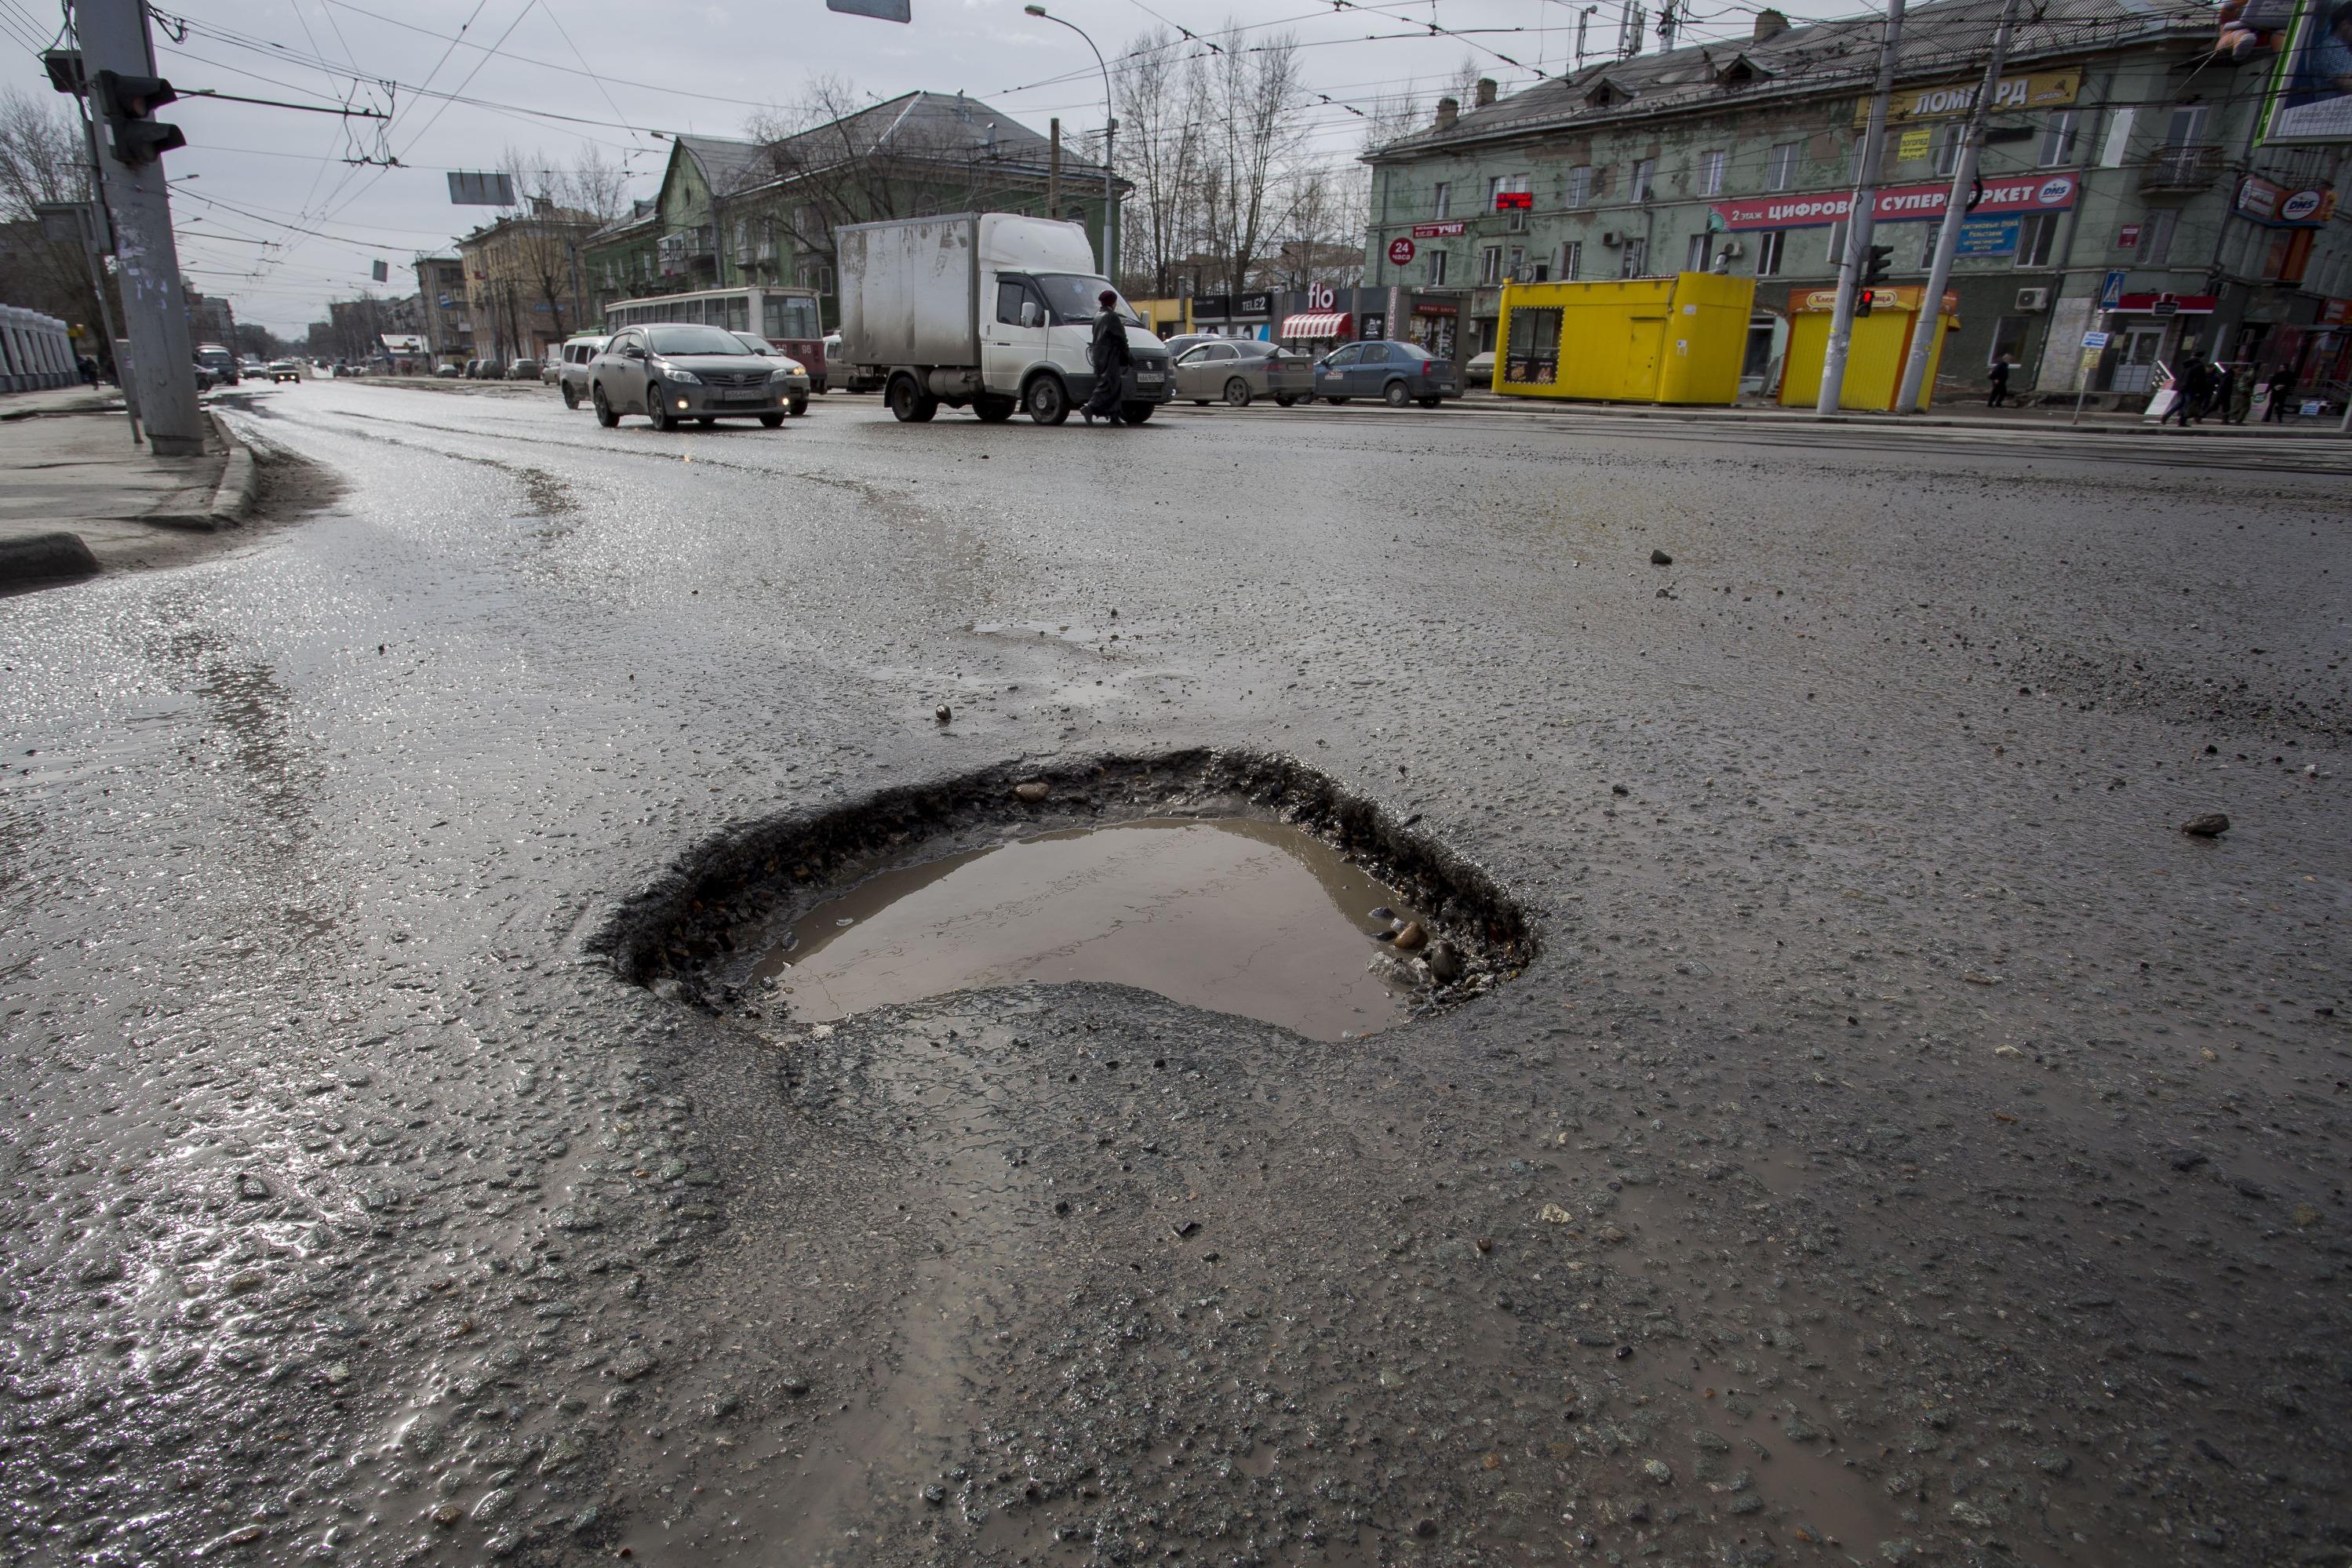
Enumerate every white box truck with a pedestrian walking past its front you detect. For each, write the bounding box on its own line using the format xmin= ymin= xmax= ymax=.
xmin=835 ymin=212 xmax=1176 ymax=425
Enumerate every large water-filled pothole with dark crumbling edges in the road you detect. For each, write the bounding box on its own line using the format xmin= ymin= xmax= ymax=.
xmin=602 ymin=752 xmax=1534 ymax=1039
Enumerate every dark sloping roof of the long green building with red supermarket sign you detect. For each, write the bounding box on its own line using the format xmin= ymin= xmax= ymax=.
xmin=1369 ymin=0 xmax=2213 ymax=162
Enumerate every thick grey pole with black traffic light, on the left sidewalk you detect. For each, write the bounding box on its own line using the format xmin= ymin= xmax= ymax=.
xmin=73 ymin=0 xmax=205 ymax=456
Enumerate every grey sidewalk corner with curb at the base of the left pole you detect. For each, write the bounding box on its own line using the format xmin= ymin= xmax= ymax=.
xmin=0 ymin=388 xmax=257 ymax=592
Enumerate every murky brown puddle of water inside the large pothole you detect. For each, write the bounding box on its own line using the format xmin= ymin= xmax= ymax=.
xmin=752 ymin=818 xmax=1416 ymax=1039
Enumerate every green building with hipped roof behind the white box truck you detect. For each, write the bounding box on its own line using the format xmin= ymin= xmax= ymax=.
xmin=584 ymin=92 xmax=1127 ymax=327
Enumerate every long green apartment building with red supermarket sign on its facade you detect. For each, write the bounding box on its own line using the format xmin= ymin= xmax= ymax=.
xmin=1367 ymin=0 xmax=2352 ymax=402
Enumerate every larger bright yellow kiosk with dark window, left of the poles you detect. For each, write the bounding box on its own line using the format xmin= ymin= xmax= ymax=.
xmin=1494 ymin=273 xmax=1757 ymax=406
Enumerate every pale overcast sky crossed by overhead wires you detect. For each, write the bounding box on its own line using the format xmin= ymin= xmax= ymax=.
xmin=27 ymin=0 xmax=1858 ymax=337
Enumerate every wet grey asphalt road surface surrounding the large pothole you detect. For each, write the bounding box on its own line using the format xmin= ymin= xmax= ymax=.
xmin=0 ymin=384 xmax=2352 ymax=1566
